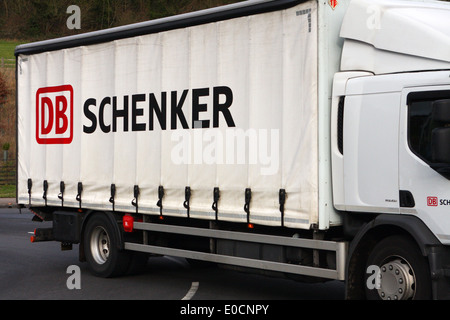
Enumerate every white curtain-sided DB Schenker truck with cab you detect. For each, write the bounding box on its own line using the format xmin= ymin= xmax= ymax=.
xmin=15 ymin=0 xmax=450 ymax=299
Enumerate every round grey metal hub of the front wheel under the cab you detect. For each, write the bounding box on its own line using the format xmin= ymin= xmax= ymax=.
xmin=378 ymin=258 xmax=415 ymax=300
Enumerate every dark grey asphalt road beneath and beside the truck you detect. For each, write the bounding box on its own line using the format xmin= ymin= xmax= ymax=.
xmin=0 ymin=208 xmax=344 ymax=301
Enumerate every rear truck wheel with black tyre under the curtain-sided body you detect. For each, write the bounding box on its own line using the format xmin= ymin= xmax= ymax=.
xmin=83 ymin=214 xmax=130 ymax=278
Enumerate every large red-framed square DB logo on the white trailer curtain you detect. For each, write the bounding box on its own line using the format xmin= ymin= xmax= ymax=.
xmin=36 ymin=85 xmax=73 ymax=144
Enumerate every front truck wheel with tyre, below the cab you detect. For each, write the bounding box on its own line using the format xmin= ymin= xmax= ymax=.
xmin=365 ymin=236 xmax=431 ymax=300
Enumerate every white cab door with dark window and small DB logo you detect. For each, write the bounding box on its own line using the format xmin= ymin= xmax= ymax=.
xmin=399 ymin=86 xmax=450 ymax=243
